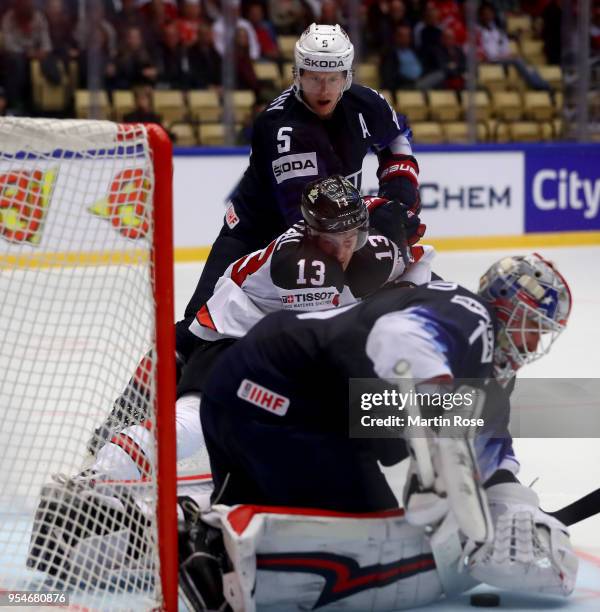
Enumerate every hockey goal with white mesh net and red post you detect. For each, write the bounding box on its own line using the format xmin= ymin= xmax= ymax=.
xmin=0 ymin=118 xmax=177 ymax=609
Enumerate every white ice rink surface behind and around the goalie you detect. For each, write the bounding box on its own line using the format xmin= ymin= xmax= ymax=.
xmin=0 ymin=247 xmax=600 ymax=611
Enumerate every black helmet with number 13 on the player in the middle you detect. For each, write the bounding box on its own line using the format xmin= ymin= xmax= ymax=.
xmin=300 ymin=175 xmax=369 ymax=250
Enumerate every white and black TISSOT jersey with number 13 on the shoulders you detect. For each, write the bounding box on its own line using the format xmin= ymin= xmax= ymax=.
xmin=190 ymin=222 xmax=434 ymax=340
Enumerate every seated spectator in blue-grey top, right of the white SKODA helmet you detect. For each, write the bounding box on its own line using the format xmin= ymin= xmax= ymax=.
xmin=380 ymin=24 xmax=445 ymax=90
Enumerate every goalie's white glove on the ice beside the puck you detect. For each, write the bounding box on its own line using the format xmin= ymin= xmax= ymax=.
xmin=463 ymin=483 xmax=578 ymax=596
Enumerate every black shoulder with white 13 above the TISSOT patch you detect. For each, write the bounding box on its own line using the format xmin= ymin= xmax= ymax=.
xmin=271 ymin=234 xmax=344 ymax=292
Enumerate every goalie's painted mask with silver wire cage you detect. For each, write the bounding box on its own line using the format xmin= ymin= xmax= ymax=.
xmin=478 ymin=253 xmax=571 ymax=384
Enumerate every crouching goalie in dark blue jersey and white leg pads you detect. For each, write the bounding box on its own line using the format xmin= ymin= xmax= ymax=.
xmin=176 ymin=254 xmax=577 ymax=610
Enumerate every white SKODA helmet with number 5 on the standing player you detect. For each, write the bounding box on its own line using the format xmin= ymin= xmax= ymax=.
xmin=294 ymin=23 xmax=354 ymax=91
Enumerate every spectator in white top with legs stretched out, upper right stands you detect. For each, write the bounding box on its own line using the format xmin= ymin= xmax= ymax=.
xmin=477 ymin=2 xmax=550 ymax=91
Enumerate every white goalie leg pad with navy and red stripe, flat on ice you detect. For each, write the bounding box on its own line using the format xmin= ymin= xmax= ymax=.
xmin=205 ymin=505 xmax=442 ymax=612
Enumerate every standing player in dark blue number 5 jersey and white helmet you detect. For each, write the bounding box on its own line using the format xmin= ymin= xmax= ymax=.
xmin=177 ymin=24 xmax=423 ymax=354
